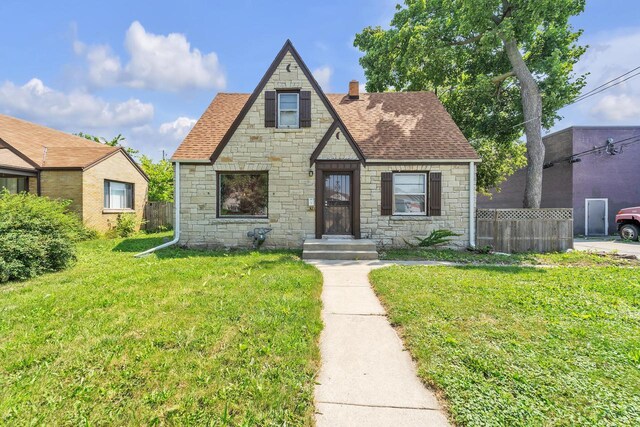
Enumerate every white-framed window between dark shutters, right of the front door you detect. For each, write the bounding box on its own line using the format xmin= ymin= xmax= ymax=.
xmin=393 ymin=173 xmax=427 ymax=215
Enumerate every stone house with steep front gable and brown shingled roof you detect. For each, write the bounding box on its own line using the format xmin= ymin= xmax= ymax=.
xmin=172 ymin=41 xmax=479 ymax=247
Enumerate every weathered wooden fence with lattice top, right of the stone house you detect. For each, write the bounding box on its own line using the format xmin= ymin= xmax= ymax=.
xmin=476 ymin=209 xmax=573 ymax=253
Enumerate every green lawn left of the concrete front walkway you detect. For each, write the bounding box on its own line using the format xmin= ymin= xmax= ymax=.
xmin=0 ymin=234 xmax=322 ymax=425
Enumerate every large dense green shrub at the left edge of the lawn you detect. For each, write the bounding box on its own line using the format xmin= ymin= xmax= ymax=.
xmin=0 ymin=191 xmax=93 ymax=282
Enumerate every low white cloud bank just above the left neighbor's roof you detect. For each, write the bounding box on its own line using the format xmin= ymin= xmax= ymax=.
xmin=0 ymin=78 xmax=154 ymax=132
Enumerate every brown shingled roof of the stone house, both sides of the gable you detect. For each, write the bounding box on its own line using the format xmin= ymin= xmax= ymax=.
xmin=173 ymin=92 xmax=478 ymax=160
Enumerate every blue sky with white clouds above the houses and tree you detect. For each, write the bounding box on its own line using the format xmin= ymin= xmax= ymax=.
xmin=0 ymin=0 xmax=640 ymax=158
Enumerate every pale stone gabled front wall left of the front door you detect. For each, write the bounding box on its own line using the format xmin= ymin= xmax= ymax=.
xmin=180 ymin=54 xmax=333 ymax=247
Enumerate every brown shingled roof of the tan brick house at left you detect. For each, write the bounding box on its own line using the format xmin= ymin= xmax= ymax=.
xmin=0 ymin=114 xmax=120 ymax=168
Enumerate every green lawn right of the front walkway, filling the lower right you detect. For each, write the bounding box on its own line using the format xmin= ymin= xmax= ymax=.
xmin=371 ymin=266 xmax=640 ymax=426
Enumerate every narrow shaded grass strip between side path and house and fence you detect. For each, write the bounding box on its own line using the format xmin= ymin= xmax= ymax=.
xmin=380 ymin=248 xmax=640 ymax=267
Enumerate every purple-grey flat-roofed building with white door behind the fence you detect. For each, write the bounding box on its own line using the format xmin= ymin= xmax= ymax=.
xmin=478 ymin=126 xmax=640 ymax=236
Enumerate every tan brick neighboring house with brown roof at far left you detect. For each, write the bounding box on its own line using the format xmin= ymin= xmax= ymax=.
xmin=0 ymin=114 xmax=148 ymax=231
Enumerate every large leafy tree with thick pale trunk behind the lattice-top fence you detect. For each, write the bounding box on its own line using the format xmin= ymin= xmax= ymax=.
xmin=354 ymin=0 xmax=585 ymax=207
